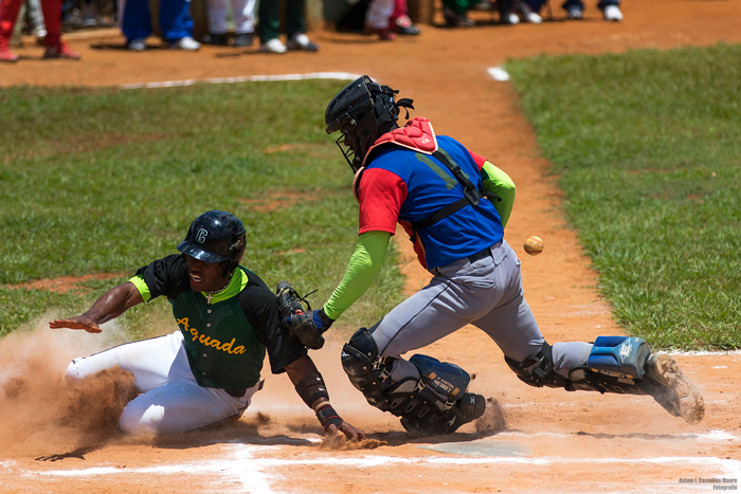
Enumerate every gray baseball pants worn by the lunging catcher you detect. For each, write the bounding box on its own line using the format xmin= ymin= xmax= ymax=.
xmin=370 ymin=240 xmax=592 ymax=382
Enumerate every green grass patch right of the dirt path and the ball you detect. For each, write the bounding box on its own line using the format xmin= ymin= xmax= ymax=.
xmin=506 ymin=44 xmax=741 ymax=349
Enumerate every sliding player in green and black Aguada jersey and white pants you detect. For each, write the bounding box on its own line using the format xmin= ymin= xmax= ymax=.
xmin=49 ymin=210 xmax=365 ymax=439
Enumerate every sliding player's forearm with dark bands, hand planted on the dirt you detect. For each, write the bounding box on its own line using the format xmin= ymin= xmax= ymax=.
xmin=286 ymin=355 xmax=365 ymax=439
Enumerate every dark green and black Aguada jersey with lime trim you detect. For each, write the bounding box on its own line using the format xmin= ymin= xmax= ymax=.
xmin=130 ymin=254 xmax=307 ymax=388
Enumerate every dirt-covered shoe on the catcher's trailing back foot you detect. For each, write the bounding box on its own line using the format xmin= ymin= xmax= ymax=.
xmin=645 ymin=354 xmax=705 ymax=424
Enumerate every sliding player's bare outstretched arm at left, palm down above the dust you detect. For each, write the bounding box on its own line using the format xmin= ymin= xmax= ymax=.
xmin=49 ymin=282 xmax=144 ymax=333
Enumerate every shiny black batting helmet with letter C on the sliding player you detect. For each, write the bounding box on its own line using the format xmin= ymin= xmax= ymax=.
xmin=177 ymin=210 xmax=246 ymax=278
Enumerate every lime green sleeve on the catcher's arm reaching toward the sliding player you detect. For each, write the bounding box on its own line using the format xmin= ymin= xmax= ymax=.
xmin=324 ymin=231 xmax=391 ymax=319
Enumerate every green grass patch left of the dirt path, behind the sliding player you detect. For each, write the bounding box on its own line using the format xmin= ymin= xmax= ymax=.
xmin=0 ymin=81 xmax=402 ymax=342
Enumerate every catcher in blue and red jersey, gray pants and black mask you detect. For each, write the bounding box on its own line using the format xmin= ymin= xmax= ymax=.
xmin=290 ymin=76 xmax=704 ymax=435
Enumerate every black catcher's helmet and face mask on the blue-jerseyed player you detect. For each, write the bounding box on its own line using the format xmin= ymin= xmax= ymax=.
xmin=324 ymin=75 xmax=414 ymax=172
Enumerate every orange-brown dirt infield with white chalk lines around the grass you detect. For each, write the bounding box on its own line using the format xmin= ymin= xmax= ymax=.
xmin=0 ymin=0 xmax=741 ymax=494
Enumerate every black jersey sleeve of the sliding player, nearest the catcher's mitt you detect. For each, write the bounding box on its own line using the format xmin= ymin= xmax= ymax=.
xmin=239 ymin=271 xmax=308 ymax=374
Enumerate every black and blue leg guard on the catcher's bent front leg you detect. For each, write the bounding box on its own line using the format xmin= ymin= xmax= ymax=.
xmin=342 ymin=328 xmax=486 ymax=435
